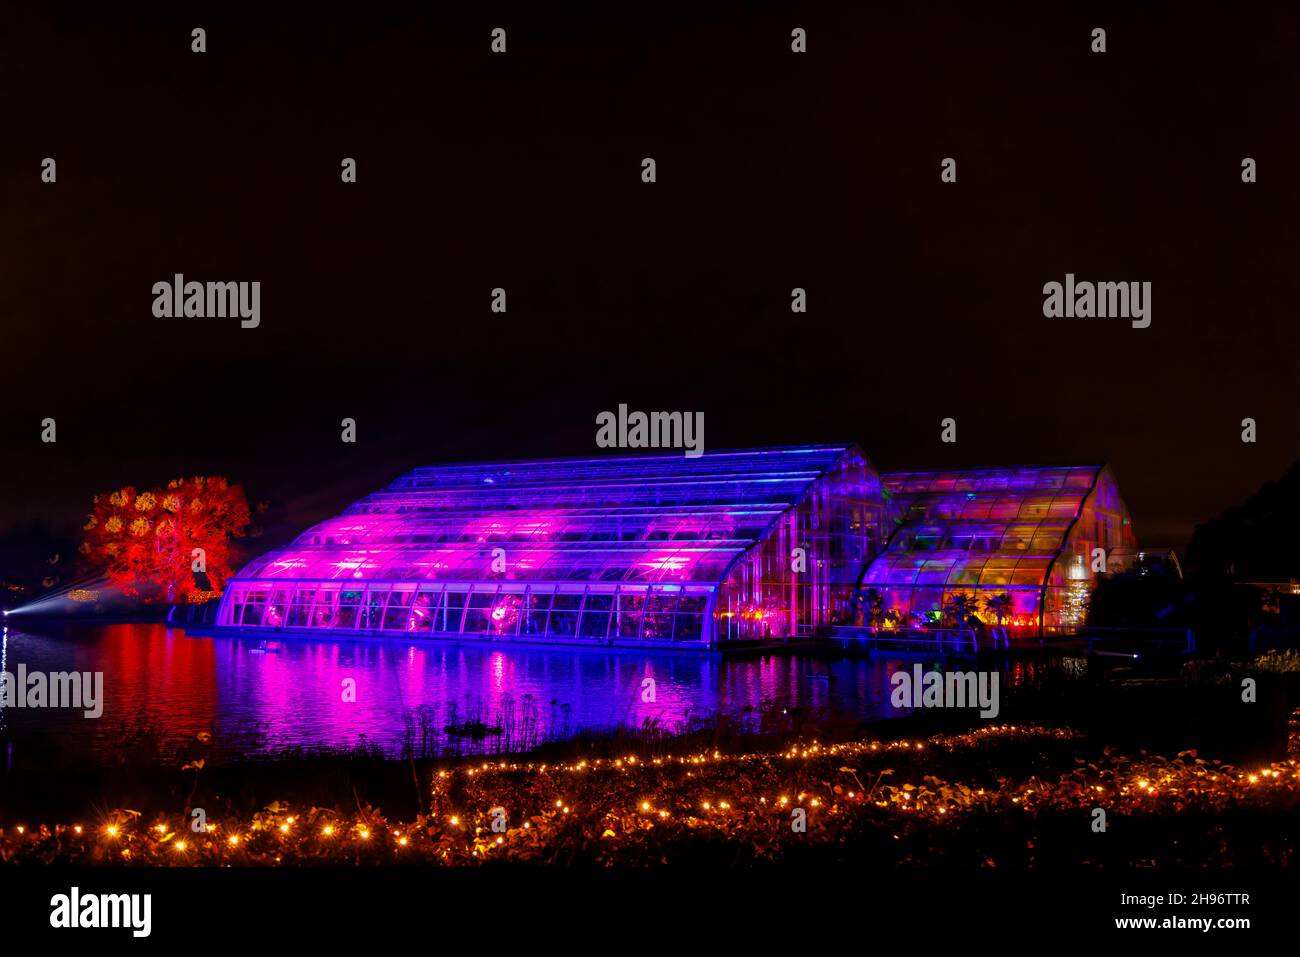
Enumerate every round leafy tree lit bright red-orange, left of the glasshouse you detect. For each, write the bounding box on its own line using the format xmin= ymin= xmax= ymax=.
xmin=81 ymin=476 xmax=250 ymax=602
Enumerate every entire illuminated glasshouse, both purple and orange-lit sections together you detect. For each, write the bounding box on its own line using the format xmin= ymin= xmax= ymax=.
xmin=217 ymin=445 xmax=1135 ymax=648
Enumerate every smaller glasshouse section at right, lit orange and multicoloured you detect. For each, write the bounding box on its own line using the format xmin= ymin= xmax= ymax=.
xmin=863 ymin=465 xmax=1136 ymax=631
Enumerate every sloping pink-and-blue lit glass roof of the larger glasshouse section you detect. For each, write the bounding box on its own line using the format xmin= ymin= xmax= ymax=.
xmin=235 ymin=445 xmax=853 ymax=584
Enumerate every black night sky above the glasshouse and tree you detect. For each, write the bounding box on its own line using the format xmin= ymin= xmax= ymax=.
xmin=0 ymin=3 xmax=1300 ymax=545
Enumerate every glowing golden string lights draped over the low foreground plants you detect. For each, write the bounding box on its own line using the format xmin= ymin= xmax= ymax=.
xmin=0 ymin=726 xmax=1300 ymax=866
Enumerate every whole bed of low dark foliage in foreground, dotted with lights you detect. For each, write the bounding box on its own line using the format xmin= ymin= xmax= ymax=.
xmin=0 ymin=726 xmax=1300 ymax=866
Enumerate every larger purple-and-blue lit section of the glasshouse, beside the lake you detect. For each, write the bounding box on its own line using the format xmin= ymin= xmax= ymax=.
xmin=217 ymin=445 xmax=889 ymax=649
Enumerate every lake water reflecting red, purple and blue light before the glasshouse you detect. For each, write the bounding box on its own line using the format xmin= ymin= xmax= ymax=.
xmin=0 ymin=624 xmax=941 ymax=759
